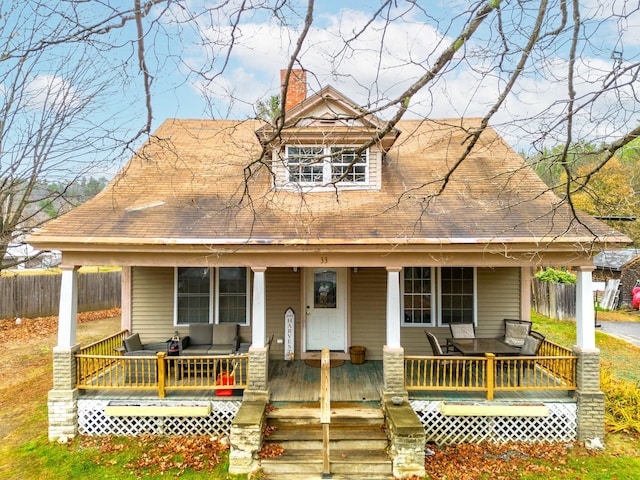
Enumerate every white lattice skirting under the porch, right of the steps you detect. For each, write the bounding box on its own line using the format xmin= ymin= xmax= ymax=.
xmin=410 ymin=400 xmax=578 ymax=445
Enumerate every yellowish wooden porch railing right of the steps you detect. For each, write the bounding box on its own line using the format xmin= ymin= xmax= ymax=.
xmin=404 ymin=341 xmax=577 ymax=400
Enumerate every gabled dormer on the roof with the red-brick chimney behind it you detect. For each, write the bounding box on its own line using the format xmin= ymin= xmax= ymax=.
xmin=256 ymin=70 xmax=400 ymax=192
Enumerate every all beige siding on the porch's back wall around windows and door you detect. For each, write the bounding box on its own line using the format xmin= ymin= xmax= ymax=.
xmin=132 ymin=267 xmax=520 ymax=360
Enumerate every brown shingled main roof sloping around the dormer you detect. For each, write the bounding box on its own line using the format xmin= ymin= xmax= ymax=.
xmin=29 ymin=119 xmax=629 ymax=252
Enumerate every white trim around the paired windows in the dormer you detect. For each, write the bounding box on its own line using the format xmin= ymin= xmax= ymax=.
xmin=284 ymin=144 xmax=375 ymax=191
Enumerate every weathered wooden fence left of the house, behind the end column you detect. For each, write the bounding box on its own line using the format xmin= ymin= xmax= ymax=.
xmin=0 ymin=271 xmax=121 ymax=318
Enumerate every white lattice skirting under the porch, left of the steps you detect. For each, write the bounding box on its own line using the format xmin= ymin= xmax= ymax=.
xmin=78 ymin=400 xmax=242 ymax=436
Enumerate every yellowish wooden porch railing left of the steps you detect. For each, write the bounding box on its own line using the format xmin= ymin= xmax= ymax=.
xmin=76 ymin=352 xmax=249 ymax=398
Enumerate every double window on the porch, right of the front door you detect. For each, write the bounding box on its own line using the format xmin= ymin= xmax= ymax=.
xmin=402 ymin=267 xmax=476 ymax=326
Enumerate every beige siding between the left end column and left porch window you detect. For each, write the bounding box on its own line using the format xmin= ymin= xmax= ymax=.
xmin=131 ymin=267 xmax=175 ymax=343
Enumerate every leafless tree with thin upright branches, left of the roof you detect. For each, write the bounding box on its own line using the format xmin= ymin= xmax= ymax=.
xmin=0 ymin=2 xmax=168 ymax=270
